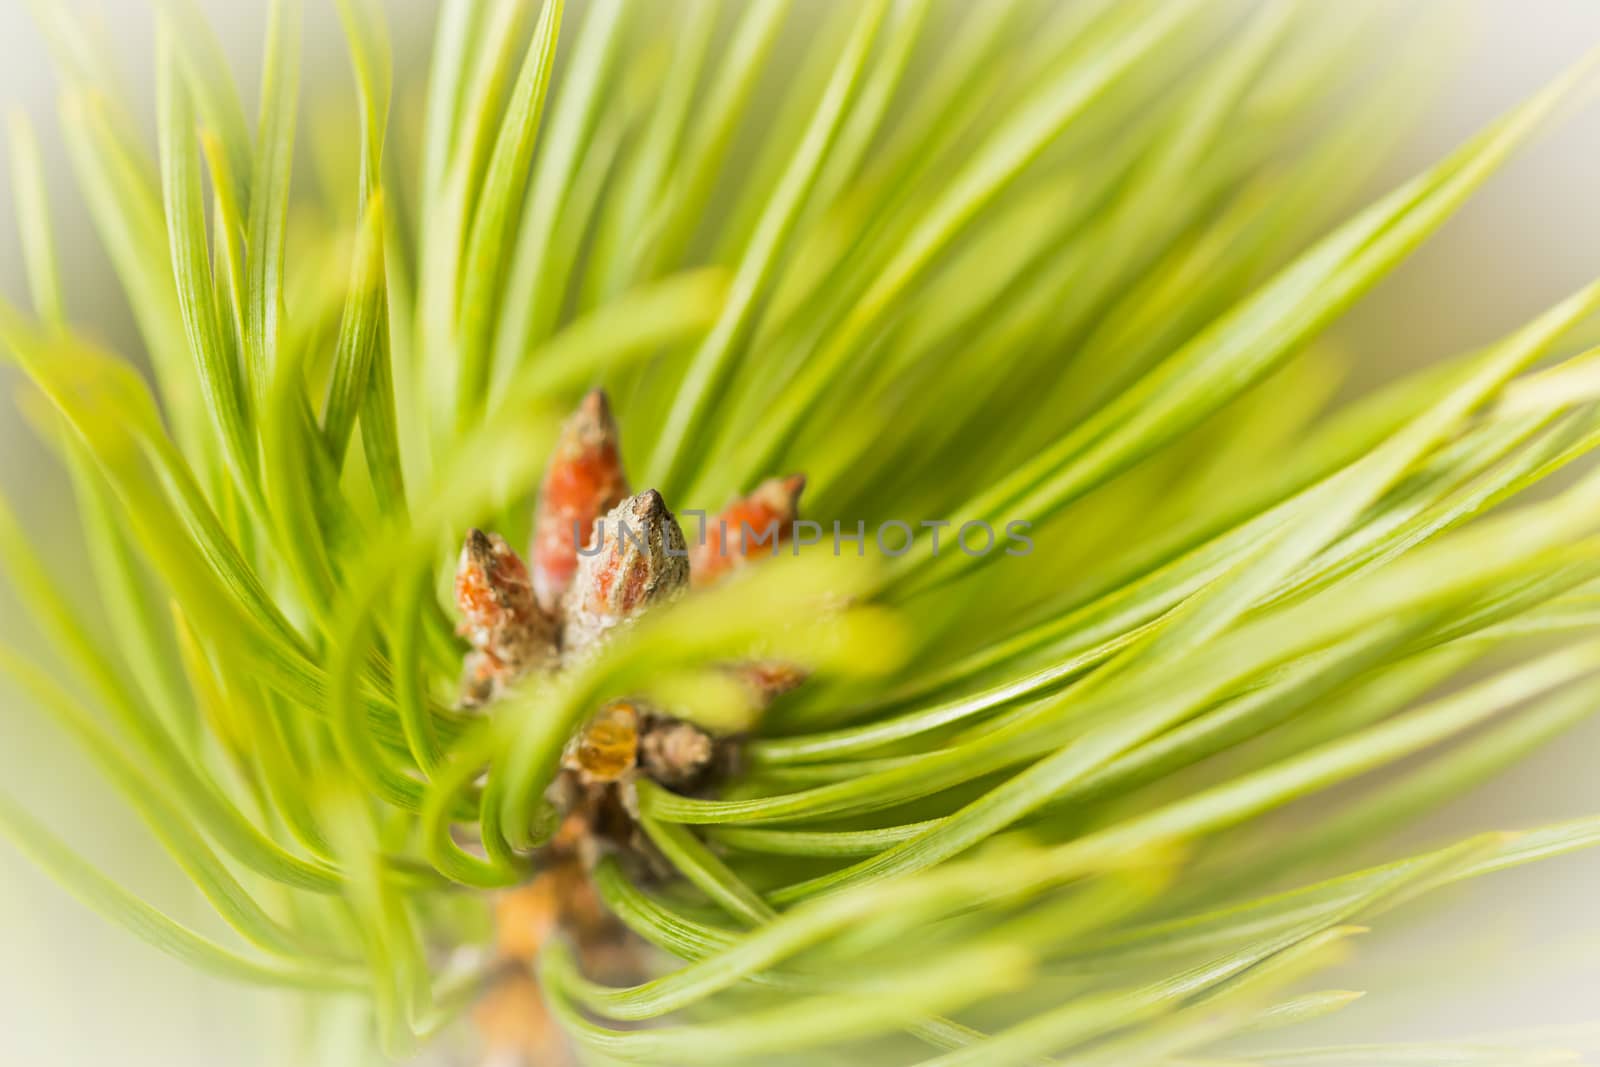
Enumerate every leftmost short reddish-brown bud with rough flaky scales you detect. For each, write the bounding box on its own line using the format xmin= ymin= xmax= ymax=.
xmin=456 ymin=530 xmax=555 ymax=694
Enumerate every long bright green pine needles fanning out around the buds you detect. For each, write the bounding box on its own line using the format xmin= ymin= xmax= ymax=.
xmin=0 ymin=0 xmax=1600 ymax=1067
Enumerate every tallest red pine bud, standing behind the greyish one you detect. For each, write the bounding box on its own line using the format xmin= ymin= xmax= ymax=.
xmin=533 ymin=389 xmax=627 ymax=616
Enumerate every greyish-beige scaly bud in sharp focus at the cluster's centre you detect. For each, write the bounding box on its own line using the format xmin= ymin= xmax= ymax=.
xmin=562 ymin=490 xmax=690 ymax=656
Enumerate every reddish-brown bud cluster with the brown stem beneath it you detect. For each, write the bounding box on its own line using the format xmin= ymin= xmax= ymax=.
xmin=456 ymin=390 xmax=805 ymax=1056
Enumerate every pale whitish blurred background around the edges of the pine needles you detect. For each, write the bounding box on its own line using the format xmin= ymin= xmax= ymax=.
xmin=0 ymin=0 xmax=1600 ymax=1067
